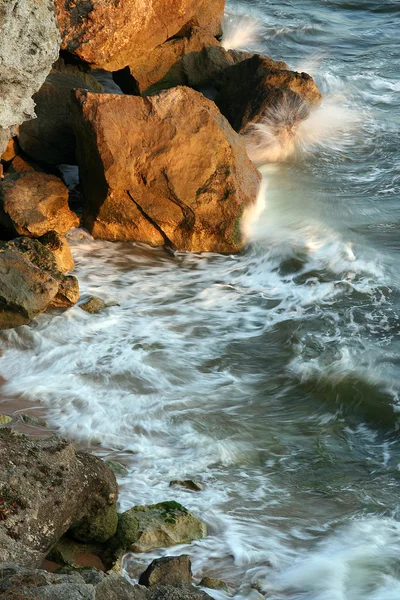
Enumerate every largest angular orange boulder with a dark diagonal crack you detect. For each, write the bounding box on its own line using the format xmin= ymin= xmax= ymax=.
xmin=71 ymin=87 xmax=260 ymax=252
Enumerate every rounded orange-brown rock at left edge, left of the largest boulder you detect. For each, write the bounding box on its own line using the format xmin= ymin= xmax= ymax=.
xmin=0 ymin=172 xmax=79 ymax=237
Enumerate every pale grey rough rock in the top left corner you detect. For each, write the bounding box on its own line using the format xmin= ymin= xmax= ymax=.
xmin=0 ymin=0 xmax=60 ymax=154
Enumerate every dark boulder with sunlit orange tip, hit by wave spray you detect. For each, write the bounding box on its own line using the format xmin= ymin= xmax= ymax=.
xmin=215 ymin=54 xmax=322 ymax=133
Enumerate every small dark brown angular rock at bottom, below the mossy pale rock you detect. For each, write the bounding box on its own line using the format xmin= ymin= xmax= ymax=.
xmin=139 ymin=554 xmax=192 ymax=587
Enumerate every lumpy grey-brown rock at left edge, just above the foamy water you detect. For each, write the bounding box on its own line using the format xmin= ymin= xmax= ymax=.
xmin=0 ymin=238 xmax=79 ymax=329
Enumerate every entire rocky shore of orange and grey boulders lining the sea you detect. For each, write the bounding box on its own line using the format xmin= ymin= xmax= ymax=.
xmin=0 ymin=0 xmax=321 ymax=600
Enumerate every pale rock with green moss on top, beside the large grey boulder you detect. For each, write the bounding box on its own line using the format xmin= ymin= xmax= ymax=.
xmin=115 ymin=502 xmax=207 ymax=552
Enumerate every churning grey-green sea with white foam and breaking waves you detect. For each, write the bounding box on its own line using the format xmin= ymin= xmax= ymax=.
xmin=0 ymin=0 xmax=400 ymax=600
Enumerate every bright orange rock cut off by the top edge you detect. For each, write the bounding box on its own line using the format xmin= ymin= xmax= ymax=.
xmin=55 ymin=0 xmax=224 ymax=71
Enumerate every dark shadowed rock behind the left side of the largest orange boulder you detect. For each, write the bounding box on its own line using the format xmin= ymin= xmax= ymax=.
xmin=19 ymin=61 xmax=103 ymax=165
